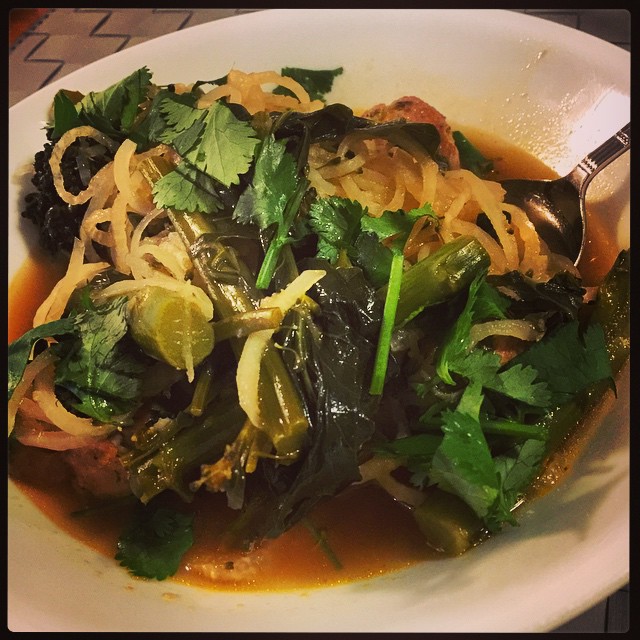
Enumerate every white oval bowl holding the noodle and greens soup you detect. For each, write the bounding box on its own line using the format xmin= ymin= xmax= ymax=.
xmin=8 ymin=9 xmax=630 ymax=632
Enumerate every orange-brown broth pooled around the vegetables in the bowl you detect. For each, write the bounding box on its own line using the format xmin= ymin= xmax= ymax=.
xmin=9 ymin=132 xmax=617 ymax=590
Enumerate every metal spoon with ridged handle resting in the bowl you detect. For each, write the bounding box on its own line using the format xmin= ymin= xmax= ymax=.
xmin=500 ymin=123 xmax=631 ymax=264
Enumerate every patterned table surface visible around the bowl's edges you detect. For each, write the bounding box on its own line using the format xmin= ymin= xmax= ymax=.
xmin=8 ymin=8 xmax=631 ymax=633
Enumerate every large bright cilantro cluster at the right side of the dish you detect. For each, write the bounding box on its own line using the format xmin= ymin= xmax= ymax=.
xmin=378 ymin=264 xmax=612 ymax=531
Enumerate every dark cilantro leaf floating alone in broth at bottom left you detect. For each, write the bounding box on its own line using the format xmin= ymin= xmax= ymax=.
xmin=115 ymin=506 xmax=193 ymax=580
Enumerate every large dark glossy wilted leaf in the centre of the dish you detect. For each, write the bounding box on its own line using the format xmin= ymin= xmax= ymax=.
xmin=236 ymin=260 xmax=381 ymax=540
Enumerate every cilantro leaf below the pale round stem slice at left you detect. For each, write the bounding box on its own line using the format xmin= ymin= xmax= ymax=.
xmin=55 ymin=297 xmax=144 ymax=422
